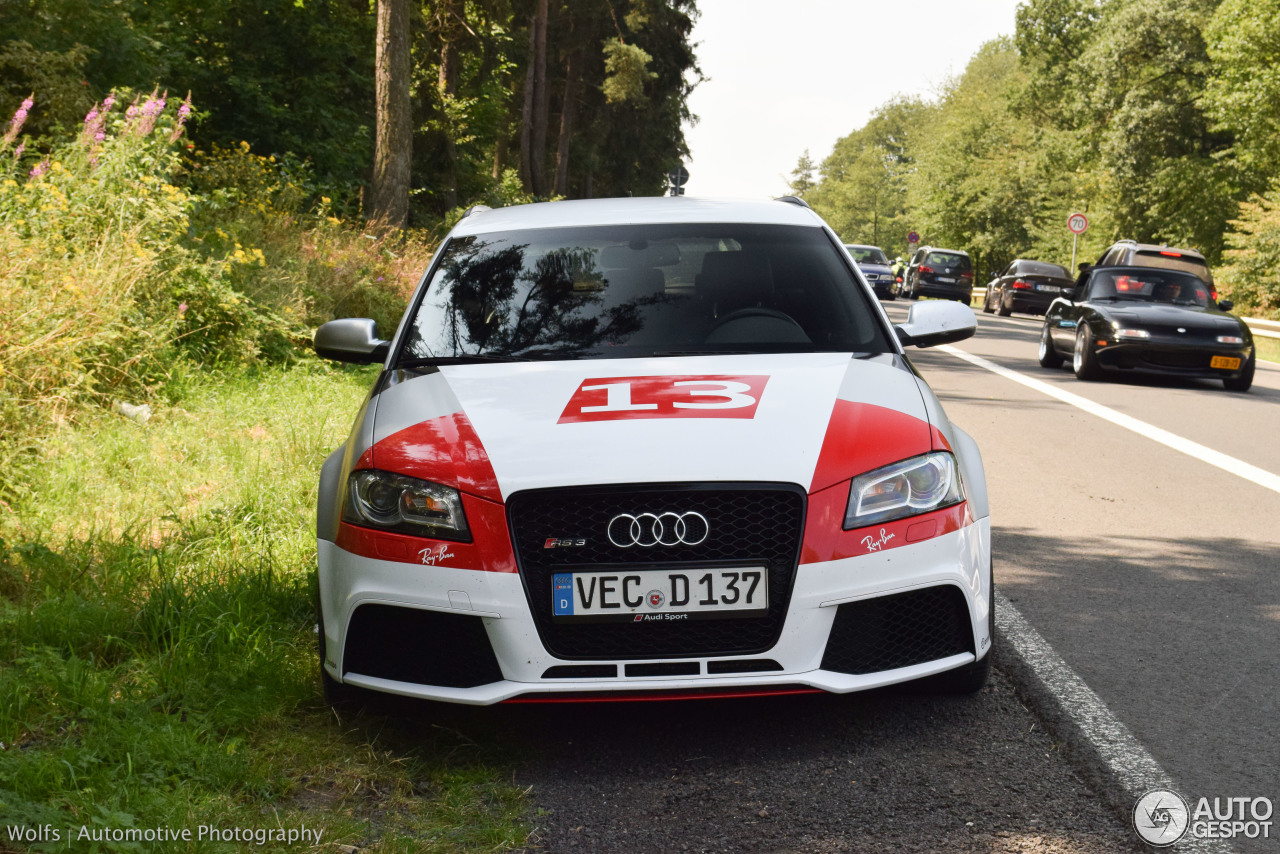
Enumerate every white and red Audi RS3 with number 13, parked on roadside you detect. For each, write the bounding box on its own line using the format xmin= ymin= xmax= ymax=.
xmin=315 ymin=197 xmax=993 ymax=704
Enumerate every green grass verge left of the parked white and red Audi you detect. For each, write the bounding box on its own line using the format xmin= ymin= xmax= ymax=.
xmin=0 ymin=362 xmax=527 ymax=851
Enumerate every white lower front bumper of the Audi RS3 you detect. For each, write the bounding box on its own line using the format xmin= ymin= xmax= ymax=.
xmin=319 ymin=519 xmax=992 ymax=705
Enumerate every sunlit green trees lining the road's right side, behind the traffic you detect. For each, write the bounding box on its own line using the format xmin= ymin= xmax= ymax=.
xmin=796 ymin=0 xmax=1280 ymax=312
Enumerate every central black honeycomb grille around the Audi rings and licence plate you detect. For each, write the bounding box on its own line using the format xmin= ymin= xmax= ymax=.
xmin=507 ymin=484 xmax=805 ymax=659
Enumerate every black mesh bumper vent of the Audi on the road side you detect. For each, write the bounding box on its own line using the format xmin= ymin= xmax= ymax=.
xmin=822 ymin=584 xmax=973 ymax=675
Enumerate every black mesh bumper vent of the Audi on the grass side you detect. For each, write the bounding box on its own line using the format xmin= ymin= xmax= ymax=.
xmin=342 ymin=604 xmax=502 ymax=688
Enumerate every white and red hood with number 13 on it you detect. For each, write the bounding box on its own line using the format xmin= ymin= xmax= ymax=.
xmin=366 ymin=353 xmax=946 ymax=501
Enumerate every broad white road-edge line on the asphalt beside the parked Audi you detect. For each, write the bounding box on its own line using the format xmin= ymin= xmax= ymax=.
xmin=996 ymin=590 xmax=1233 ymax=854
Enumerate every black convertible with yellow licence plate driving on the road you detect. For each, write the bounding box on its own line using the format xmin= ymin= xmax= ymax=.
xmin=1039 ymin=266 xmax=1256 ymax=392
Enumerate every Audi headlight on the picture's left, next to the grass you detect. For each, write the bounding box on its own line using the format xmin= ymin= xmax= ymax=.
xmin=342 ymin=469 xmax=471 ymax=543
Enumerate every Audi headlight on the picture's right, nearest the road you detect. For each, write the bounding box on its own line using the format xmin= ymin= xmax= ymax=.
xmin=845 ymin=451 xmax=964 ymax=530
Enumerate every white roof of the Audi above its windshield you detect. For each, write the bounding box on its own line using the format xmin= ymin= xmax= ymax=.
xmin=453 ymin=196 xmax=823 ymax=236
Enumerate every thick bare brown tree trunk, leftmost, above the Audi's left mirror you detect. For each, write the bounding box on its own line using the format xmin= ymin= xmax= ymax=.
xmin=365 ymin=0 xmax=413 ymax=228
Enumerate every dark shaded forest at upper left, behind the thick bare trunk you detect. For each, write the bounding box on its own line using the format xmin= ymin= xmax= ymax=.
xmin=0 ymin=0 xmax=699 ymax=225
